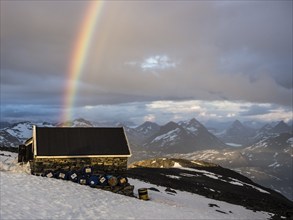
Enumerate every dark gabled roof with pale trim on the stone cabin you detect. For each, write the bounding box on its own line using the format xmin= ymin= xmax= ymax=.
xmin=34 ymin=127 xmax=130 ymax=157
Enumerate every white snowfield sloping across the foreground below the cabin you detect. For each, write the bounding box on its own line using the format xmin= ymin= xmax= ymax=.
xmin=0 ymin=152 xmax=272 ymax=219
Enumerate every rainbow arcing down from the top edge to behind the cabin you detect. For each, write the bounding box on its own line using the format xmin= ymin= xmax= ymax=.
xmin=60 ymin=0 xmax=104 ymax=122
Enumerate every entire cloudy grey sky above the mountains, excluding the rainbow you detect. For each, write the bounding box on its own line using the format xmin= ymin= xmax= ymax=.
xmin=0 ymin=0 xmax=292 ymax=123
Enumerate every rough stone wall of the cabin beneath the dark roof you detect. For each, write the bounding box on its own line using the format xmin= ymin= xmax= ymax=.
xmin=30 ymin=157 xmax=128 ymax=175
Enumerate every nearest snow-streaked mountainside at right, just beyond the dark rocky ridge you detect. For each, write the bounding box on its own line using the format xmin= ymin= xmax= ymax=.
xmin=167 ymin=133 xmax=293 ymax=200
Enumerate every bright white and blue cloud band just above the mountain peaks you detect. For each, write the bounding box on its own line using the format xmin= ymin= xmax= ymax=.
xmin=1 ymin=100 xmax=292 ymax=125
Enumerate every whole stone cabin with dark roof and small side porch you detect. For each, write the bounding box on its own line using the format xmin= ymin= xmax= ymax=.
xmin=18 ymin=126 xmax=131 ymax=175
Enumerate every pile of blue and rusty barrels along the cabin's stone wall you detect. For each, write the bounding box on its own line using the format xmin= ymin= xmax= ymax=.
xmin=35 ymin=166 xmax=134 ymax=196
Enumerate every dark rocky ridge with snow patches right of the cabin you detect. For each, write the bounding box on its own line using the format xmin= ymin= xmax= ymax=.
xmin=128 ymin=158 xmax=293 ymax=219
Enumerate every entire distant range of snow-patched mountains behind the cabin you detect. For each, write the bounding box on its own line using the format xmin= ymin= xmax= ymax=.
xmin=0 ymin=118 xmax=293 ymax=200
